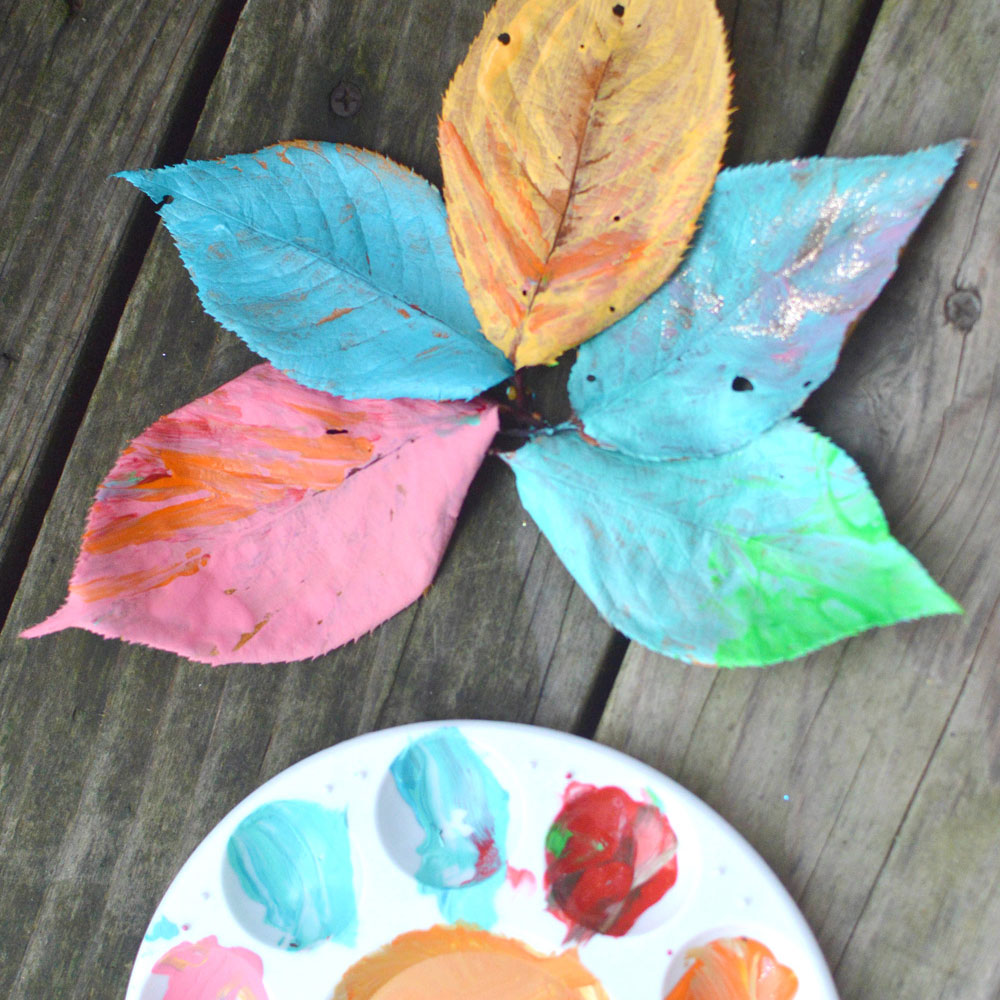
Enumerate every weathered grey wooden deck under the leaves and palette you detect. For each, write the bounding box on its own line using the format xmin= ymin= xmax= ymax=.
xmin=0 ymin=0 xmax=1000 ymax=1000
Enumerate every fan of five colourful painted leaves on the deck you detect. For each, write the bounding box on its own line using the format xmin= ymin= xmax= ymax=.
xmin=24 ymin=0 xmax=962 ymax=666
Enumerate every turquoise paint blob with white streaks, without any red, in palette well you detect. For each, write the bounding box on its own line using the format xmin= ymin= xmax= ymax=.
xmin=226 ymin=799 xmax=358 ymax=949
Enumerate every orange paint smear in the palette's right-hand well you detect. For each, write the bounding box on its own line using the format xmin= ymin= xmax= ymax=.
xmin=667 ymin=937 xmax=799 ymax=1000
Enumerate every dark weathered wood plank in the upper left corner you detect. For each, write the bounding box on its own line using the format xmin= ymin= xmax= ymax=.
xmin=0 ymin=0 xmax=240 ymax=618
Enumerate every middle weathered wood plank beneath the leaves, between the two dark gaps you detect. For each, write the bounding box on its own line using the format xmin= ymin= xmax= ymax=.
xmin=0 ymin=0 xmax=876 ymax=998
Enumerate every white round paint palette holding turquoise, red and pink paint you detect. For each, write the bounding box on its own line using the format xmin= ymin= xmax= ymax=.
xmin=126 ymin=722 xmax=837 ymax=1000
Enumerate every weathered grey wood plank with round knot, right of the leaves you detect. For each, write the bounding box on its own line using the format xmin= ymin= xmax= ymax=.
xmin=598 ymin=0 xmax=1000 ymax=1000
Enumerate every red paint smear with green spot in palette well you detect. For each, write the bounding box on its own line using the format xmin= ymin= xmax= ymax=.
xmin=545 ymin=782 xmax=677 ymax=941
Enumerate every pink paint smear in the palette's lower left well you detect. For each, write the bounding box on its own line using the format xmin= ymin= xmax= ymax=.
xmin=153 ymin=936 xmax=268 ymax=1000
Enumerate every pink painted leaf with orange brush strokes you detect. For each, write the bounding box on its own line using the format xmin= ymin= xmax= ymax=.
xmin=24 ymin=365 xmax=497 ymax=664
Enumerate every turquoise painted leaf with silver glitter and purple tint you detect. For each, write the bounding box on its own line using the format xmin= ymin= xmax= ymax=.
xmin=569 ymin=142 xmax=962 ymax=458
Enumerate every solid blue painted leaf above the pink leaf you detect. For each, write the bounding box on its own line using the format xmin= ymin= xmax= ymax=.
xmin=118 ymin=143 xmax=511 ymax=399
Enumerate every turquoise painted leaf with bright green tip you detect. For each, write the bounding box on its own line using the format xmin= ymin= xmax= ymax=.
xmin=506 ymin=419 xmax=961 ymax=666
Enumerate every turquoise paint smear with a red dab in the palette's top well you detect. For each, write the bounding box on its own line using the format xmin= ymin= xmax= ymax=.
xmin=390 ymin=726 xmax=509 ymax=928
